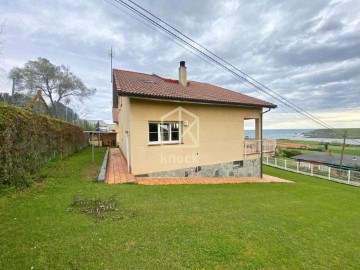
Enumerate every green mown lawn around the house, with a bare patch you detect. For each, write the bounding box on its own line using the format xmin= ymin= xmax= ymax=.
xmin=0 ymin=149 xmax=360 ymax=269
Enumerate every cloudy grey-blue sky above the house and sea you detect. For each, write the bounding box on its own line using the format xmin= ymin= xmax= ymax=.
xmin=0 ymin=0 xmax=360 ymax=129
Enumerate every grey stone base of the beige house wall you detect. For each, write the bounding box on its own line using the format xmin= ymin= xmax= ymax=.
xmin=136 ymin=158 xmax=261 ymax=177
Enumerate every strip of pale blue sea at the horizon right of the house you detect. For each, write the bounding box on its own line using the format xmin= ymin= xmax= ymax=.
xmin=245 ymin=129 xmax=360 ymax=145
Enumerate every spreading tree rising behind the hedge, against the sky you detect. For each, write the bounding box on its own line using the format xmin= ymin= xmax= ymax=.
xmin=10 ymin=57 xmax=96 ymax=117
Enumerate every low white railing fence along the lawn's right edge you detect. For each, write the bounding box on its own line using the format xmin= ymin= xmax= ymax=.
xmin=263 ymin=157 xmax=360 ymax=186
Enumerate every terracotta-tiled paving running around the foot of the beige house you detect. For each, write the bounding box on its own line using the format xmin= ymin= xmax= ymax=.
xmin=106 ymin=148 xmax=293 ymax=185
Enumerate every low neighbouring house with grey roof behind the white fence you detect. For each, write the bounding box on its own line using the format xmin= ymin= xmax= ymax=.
xmin=293 ymin=151 xmax=360 ymax=169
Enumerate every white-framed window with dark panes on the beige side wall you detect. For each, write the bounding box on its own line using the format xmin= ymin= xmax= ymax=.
xmin=149 ymin=122 xmax=180 ymax=144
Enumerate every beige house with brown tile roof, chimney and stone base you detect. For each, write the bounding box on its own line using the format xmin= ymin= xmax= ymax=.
xmin=113 ymin=61 xmax=276 ymax=177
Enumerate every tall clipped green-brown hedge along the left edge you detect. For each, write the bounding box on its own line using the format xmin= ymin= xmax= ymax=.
xmin=0 ymin=104 xmax=86 ymax=188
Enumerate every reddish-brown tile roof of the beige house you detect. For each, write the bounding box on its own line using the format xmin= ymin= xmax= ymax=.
xmin=113 ymin=69 xmax=276 ymax=108
